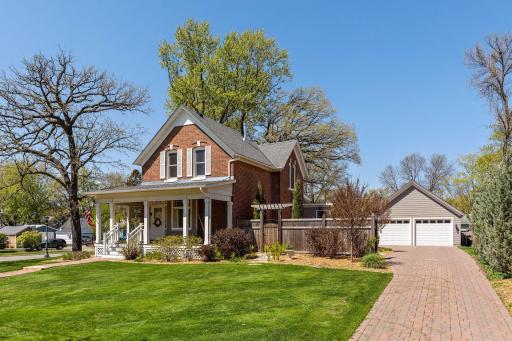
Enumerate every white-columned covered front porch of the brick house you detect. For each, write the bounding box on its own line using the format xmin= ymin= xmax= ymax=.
xmin=92 ymin=177 xmax=233 ymax=258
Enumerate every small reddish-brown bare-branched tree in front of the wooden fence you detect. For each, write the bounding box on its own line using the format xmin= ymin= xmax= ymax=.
xmin=332 ymin=179 xmax=386 ymax=261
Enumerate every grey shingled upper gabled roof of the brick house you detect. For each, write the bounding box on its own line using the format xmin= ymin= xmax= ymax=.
xmin=134 ymin=105 xmax=307 ymax=177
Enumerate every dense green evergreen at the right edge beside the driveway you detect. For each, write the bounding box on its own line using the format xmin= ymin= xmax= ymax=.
xmin=471 ymin=163 xmax=512 ymax=274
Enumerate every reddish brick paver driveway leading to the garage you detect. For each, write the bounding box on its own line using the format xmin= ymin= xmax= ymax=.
xmin=352 ymin=246 xmax=512 ymax=341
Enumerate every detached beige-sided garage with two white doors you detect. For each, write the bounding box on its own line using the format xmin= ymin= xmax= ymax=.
xmin=379 ymin=182 xmax=464 ymax=246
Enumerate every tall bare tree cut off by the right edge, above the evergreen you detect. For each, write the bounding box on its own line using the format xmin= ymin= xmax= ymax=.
xmin=466 ymin=33 xmax=512 ymax=163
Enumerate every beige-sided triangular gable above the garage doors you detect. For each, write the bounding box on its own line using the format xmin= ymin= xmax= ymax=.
xmin=388 ymin=182 xmax=464 ymax=218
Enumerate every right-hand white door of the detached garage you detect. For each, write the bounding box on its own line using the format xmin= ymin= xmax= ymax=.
xmin=416 ymin=219 xmax=453 ymax=246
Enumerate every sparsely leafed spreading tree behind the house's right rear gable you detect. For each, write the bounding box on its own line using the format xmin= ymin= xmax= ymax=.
xmin=259 ymin=87 xmax=361 ymax=202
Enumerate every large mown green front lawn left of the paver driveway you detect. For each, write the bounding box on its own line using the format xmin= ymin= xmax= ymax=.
xmin=0 ymin=262 xmax=392 ymax=340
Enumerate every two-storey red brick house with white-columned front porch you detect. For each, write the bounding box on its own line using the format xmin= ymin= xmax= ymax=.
xmin=87 ymin=106 xmax=307 ymax=254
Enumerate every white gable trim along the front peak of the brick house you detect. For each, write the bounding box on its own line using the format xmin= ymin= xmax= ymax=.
xmin=134 ymin=106 xmax=235 ymax=166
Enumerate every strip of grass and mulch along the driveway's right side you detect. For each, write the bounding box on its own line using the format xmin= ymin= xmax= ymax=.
xmin=459 ymin=246 xmax=512 ymax=315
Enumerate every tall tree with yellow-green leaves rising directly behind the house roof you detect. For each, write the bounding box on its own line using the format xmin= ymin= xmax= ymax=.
xmin=159 ymin=20 xmax=290 ymax=134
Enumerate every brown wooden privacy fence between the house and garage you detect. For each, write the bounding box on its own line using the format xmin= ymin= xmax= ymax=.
xmin=238 ymin=218 xmax=374 ymax=251
